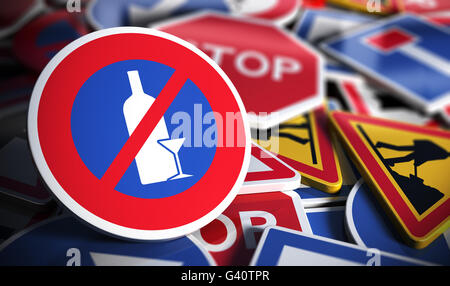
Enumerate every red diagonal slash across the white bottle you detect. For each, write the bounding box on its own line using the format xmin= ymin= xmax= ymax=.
xmin=100 ymin=71 xmax=187 ymax=189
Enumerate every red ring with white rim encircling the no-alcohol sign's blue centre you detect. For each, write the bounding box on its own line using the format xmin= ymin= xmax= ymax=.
xmin=28 ymin=27 xmax=251 ymax=239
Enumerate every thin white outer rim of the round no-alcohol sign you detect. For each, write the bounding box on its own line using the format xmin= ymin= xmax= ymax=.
xmin=27 ymin=27 xmax=251 ymax=240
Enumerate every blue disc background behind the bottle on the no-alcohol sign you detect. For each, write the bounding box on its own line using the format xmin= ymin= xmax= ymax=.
xmin=71 ymin=60 xmax=217 ymax=199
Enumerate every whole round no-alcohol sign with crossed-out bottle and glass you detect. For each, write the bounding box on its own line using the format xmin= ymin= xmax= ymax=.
xmin=28 ymin=27 xmax=251 ymax=240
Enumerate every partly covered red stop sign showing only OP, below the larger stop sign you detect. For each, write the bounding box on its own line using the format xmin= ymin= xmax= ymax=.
xmin=194 ymin=191 xmax=311 ymax=265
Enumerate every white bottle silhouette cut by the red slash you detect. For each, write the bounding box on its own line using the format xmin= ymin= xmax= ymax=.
xmin=123 ymin=70 xmax=178 ymax=185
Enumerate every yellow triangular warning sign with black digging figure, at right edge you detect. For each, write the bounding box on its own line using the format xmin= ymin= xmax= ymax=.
xmin=331 ymin=112 xmax=450 ymax=248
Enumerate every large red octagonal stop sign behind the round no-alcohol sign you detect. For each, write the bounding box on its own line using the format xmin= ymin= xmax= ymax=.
xmin=156 ymin=12 xmax=323 ymax=129
